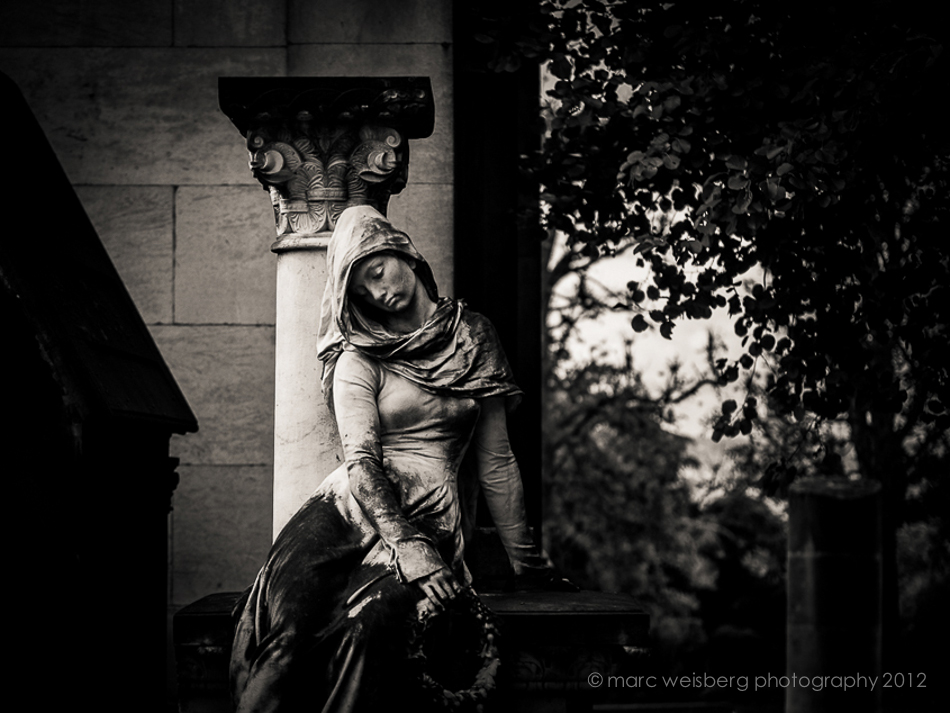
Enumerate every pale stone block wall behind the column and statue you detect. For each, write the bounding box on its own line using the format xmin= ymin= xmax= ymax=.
xmin=0 ymin=0 xmax=453 ymax=700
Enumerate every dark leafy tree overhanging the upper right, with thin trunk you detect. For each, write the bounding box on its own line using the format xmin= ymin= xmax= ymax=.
xmin=472 ymin=0 xmax=950 ymax=672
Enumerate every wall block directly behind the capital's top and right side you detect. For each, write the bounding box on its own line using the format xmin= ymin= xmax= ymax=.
xmin=288 ymin=44 xmax=453 ymax=186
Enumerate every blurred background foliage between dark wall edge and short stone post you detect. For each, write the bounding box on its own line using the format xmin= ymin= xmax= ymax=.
xmin=544 ymin=354 xmax=785 ymax=675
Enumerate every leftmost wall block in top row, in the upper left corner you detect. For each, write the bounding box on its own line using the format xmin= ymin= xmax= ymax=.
xmin=0 ymin=0 xmax=172 ymax=47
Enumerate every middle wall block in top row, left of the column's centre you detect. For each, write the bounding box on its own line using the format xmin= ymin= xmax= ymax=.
xmin=175 ymin=0 xmax=286 ymax=47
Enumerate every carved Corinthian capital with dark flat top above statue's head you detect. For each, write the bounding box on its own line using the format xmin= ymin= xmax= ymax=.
xmin=218 ymin=77 xmax=434 ymax=252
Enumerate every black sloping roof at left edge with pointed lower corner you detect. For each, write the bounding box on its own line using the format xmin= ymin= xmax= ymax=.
xmin=0 ymin=73 xmax=198 ymax=433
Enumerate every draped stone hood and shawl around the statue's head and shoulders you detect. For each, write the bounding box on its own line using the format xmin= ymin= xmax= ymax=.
xmin=318 ymin=205 xmax=521 ymax=410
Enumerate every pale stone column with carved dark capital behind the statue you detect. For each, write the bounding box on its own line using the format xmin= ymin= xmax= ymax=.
xmin=218 ymin=77 xmax=434 ymax=537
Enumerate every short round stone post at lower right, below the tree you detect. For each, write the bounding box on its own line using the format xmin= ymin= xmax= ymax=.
xmin=782 ymin=478 xmax=883 ymax=713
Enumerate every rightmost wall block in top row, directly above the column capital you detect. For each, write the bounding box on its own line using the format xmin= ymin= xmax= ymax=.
xmin=289 ymin=0 xmax=452 ymax=44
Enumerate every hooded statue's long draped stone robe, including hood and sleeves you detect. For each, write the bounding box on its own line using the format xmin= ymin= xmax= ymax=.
xmin=231 ymin=207 xmax=549 ymax=713
